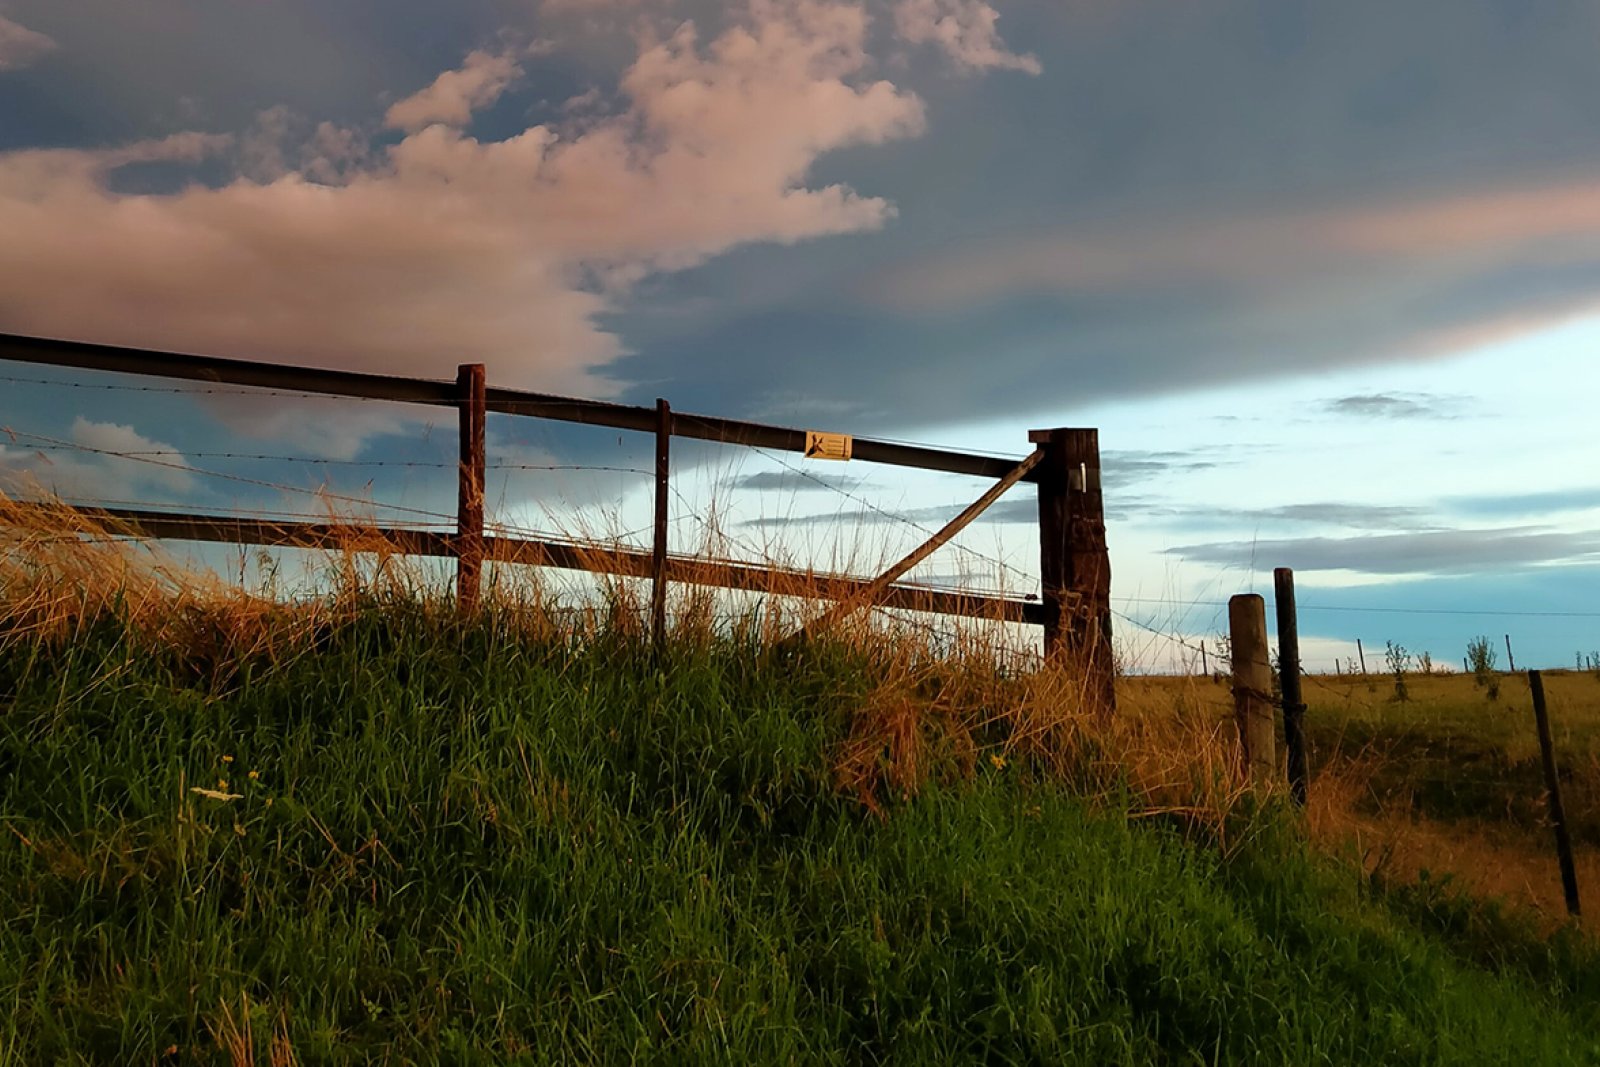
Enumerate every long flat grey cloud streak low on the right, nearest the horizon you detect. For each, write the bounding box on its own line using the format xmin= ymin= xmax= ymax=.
xmin=1168 ymin=526 xmax=1600 ymax=574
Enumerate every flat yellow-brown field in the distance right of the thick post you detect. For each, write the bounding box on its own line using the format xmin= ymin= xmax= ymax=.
xmin=1120 ymin=670 xmax=1600 ymax=923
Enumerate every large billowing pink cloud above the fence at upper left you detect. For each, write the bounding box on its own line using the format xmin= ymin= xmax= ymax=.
xmin=0 ymin=0 xmax=925 ymax=422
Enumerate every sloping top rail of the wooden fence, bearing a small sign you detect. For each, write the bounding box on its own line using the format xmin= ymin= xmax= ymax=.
xmin=0 ymin=333 xmax=1040 ymax=482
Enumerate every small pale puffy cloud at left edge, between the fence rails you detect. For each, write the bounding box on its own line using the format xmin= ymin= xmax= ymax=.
xmin=0 ymin=416 xmax=195 ymax=502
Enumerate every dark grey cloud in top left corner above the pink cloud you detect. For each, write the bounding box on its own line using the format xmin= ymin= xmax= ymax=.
xmin=0 ymin=0 xmax=509 ymax=149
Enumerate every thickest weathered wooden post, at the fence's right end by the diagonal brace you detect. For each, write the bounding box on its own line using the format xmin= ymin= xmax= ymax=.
xmin=1027 ymin=429 xmax=1117 ymax=712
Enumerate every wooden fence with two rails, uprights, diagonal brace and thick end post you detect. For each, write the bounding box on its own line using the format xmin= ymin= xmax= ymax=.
xmin=0 ymin=334 xmax=1115 ymax=707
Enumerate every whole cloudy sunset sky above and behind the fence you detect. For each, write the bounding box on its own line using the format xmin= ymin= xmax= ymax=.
xmin=0 ymin=0 xmax=1600 ymax=669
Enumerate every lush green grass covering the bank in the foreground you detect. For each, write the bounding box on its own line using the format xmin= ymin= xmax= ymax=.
xmin=0 ymin=605 xmax=1600 ymax=1067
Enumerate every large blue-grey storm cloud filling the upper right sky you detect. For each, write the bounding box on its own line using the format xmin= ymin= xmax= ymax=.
xmin=604 ymin=0 xmax=1600 ymax=429
